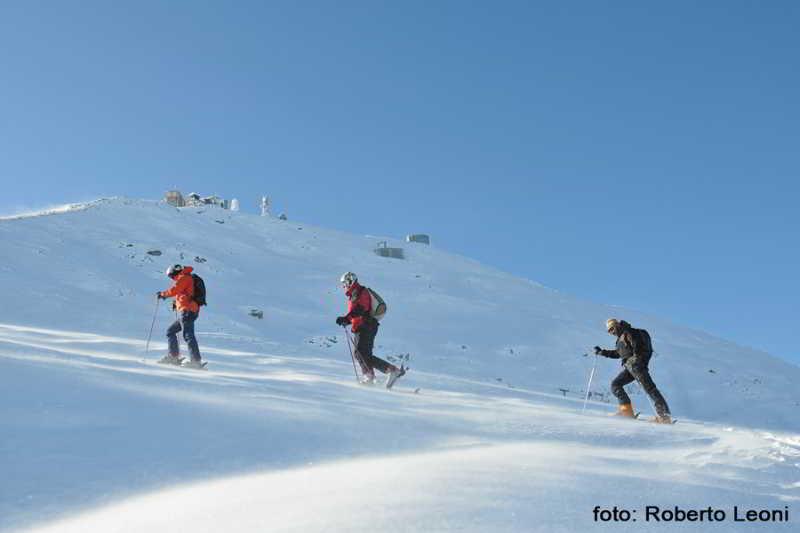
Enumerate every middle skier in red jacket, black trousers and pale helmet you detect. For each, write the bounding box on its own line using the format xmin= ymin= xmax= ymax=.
xmin=336 ymin=272 xmax=406 ymax=388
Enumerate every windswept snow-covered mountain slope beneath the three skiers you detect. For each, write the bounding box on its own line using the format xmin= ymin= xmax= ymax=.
xmin=0 ymin=199 xmax=800 ymax=531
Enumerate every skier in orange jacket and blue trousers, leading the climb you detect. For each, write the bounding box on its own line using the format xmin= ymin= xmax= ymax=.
xmin=157 ymin=265 xmax=203 ymax=368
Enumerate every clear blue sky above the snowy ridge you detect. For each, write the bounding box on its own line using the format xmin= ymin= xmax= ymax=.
xmin=0 ymin=1 xmax=800 ymax=362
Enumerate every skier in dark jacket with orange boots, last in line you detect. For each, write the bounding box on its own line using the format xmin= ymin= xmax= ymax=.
xmin=594 ymin=318 xmax=672 ymax=424
